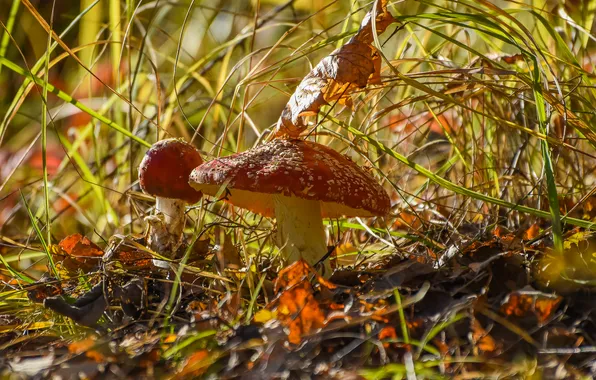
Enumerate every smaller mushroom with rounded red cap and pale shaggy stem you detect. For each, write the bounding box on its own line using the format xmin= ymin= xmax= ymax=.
xmin=139 ymin=139 xmax=203 ymax=257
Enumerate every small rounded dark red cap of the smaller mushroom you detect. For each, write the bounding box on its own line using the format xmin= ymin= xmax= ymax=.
xmin=139 ymin=139 xmax=203 ymax=203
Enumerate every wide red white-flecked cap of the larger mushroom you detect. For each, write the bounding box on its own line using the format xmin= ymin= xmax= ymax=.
xmin=190 ymin=139 xmax=391 ymax=218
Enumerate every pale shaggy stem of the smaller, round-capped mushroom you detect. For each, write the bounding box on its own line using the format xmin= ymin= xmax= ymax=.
xmin=147 ymin=197 xmax=186 ymax=266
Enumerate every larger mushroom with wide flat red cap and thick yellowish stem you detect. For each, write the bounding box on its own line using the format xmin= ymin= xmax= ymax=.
xmin=190 ymin=139 xmax=390 ymax=275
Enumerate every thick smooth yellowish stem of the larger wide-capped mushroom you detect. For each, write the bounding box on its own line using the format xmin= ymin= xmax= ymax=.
xmin=274 ymin=195 xmax=331 ymax=277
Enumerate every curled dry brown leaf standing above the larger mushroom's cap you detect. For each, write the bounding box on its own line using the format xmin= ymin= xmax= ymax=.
xmin=274 ymin=0 xmax=395 ymax=138
